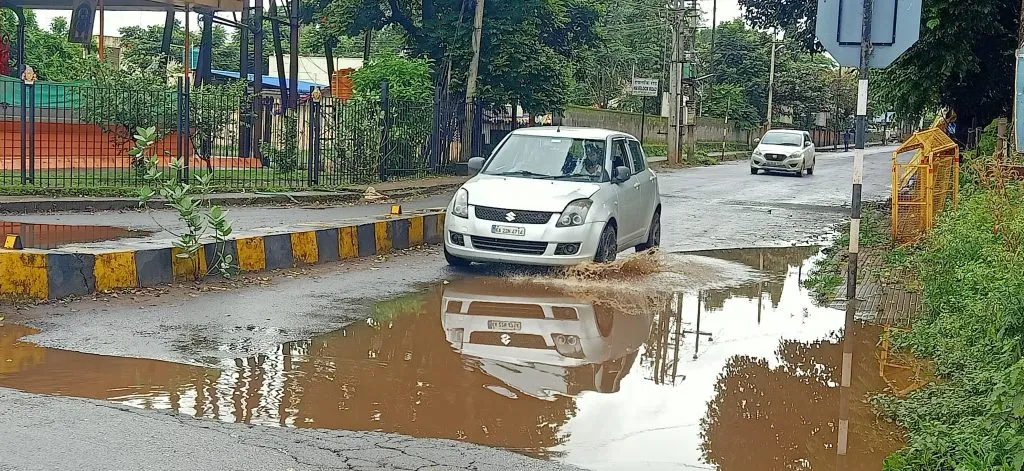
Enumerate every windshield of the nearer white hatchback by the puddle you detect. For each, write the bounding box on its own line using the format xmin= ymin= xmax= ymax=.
xmin=482 ymin=134 xmax=608 ymax=182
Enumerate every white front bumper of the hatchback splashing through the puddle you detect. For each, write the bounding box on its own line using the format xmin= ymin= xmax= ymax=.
xmin=444 ymin=209 xmax=605 ymax=266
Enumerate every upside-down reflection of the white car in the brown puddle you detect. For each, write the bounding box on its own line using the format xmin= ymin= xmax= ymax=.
xmin=441 ymin=281 xmax=653 ymax=400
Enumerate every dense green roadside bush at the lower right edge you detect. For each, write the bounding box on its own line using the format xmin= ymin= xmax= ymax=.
xmin=873 ymin=174 xmax=1024 ymax=471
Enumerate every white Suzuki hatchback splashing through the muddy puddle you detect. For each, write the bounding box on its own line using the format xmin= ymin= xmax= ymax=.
xmin=444 ymin=127 xmax=662 ymax=266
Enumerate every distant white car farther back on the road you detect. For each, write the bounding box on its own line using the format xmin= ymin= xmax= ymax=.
xmin=751 ymin=129 xmax=815 ymax=177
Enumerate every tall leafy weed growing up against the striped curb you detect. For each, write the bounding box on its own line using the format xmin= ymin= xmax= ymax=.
xmin=129 ymin=127 xmax=238 ymax=279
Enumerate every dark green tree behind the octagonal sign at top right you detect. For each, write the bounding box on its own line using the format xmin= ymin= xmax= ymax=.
xmin=739 ymin=0 xmax=1021 ymax=132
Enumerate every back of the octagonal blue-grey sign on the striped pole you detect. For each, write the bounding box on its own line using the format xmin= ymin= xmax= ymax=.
xmin=816 ymin=0 xmax=922 ymax=69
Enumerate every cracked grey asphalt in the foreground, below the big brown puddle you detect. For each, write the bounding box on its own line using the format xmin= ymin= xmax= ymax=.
xmin=0 ymin=389 xmax=579 ymax=471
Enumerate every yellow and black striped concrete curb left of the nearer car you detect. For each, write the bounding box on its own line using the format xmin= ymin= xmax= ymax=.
xmin=0 ymin=212 xmax=444 ymax=299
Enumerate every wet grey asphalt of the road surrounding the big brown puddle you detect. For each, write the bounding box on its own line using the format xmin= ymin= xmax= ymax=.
xmin=0 ymin=148 xmax=889 ymax=470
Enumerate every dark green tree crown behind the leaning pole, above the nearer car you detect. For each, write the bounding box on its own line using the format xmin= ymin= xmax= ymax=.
xmin=323 ymin=0 xmax=598 ymax=113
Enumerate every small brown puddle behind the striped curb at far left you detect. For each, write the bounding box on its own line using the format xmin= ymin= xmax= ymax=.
xmin=0 ymin=221 xmax=153 ymax=249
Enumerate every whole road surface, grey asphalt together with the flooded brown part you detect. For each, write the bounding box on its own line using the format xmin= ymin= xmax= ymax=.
xmin=0 ymin=151 xmax=890 ymax=470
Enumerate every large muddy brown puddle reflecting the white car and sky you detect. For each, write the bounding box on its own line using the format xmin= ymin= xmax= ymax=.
xmin=0 ymin=248 xmax=901 ymax=471
